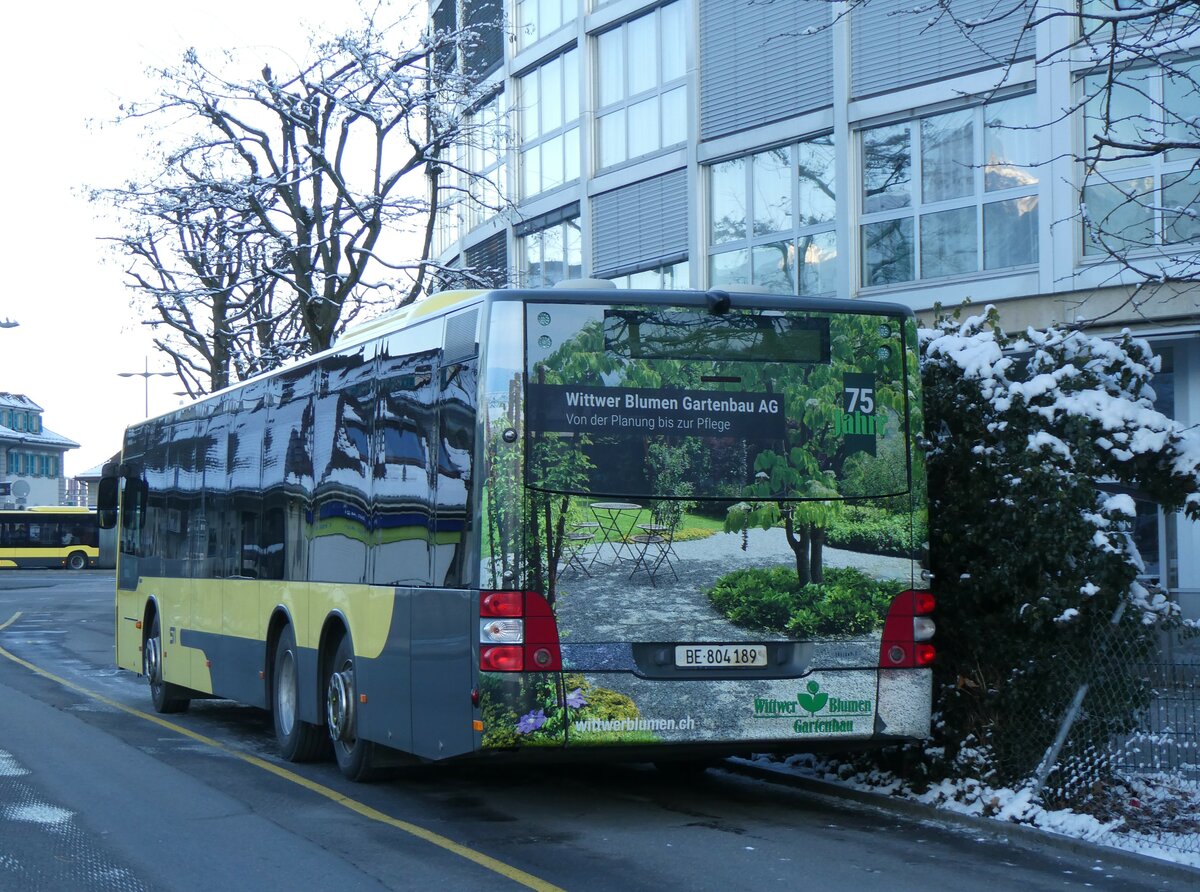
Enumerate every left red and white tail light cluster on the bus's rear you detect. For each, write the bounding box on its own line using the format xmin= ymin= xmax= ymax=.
xmin=479 ymin=591 xmax=563 ymax=672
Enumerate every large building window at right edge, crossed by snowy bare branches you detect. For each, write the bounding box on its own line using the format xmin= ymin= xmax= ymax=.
xmin=1081 ymin=60 xmax=1200 ymax=257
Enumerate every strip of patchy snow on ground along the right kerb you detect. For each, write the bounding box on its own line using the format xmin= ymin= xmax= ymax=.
xmin=755 ymin=754 xmax=1200 ymax=868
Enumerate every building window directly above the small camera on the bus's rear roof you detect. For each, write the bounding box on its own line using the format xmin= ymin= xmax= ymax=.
xmin=708 ymin=136 xmax=838 ymax=294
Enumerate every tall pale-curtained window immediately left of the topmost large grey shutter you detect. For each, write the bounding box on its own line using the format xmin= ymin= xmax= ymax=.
xmin=596 ymin=2 xmax=688 ymax=168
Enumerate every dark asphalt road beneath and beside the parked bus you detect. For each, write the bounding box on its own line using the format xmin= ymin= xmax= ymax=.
xmin=0 ymin=570 xmax=1188 ymax=892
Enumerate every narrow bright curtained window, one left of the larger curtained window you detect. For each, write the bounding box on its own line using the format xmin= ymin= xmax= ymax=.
xmin=517 ymin=49 xmax=580 ymax=198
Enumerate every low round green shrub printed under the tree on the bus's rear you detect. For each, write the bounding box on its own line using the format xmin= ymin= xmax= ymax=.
xmin=708 ymin=567 xmax=899 ymax=637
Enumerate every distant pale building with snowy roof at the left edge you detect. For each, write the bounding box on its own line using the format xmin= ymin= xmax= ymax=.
xmin=0 ymin=393 xmax=79 ymax=508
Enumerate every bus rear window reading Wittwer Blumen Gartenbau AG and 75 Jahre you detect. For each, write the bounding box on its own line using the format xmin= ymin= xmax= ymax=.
xmin=524 ymin=301 xmax=916 ymax=502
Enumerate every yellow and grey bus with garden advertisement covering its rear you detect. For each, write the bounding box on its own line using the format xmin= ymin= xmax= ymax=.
xmin=100 ymin=287 xmax=935 ymax=780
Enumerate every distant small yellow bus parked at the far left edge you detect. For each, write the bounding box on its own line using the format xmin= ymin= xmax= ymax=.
xmin=0 ymin=507 xmax=100 ymax=570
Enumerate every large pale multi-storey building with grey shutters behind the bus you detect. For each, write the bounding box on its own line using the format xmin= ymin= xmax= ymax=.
xmin=430 ymin=0 xmax=1200 ymax=616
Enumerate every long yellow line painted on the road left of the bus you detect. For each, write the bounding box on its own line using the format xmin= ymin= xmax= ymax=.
xmin=0 ymin=611 xmax=563 ymax=892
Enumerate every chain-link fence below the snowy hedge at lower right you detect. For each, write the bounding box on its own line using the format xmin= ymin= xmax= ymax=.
xmin=1030 ymin=629 xmax=1200 ymax=854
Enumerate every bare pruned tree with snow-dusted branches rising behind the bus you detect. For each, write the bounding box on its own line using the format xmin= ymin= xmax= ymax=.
xmin=94 ymin=4 xmax=501 ymax=391
